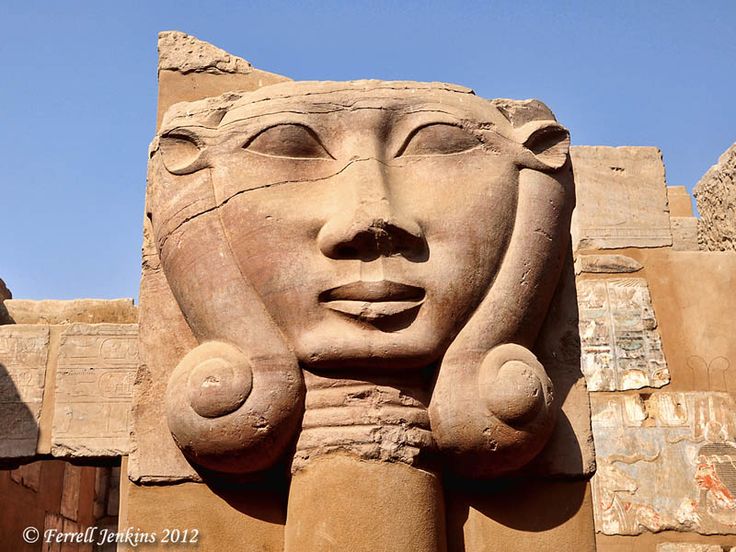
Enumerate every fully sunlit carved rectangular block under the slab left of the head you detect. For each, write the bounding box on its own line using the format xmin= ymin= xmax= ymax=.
xmin=51 ymin=324 xmax=138 ymax=456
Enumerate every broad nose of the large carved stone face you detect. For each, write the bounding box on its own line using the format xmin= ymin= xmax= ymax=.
xmin=317 ymin=160 xmax=428 ymax=261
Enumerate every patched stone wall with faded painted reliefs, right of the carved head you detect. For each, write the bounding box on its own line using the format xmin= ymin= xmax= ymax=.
xmin=576 ymin=144 xmax=736 ymax=552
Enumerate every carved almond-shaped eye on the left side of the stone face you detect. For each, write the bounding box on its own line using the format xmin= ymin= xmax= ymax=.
xmin=243 ymin=124 xmax=334 ymax=159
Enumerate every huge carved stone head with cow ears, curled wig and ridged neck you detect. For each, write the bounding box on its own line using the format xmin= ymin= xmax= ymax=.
xmin=148 ymin=81 xmax=574 ymax=477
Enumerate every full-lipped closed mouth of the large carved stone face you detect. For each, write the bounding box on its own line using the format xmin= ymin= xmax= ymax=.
xmin=319 ymin=280 xmax=425 ymax=322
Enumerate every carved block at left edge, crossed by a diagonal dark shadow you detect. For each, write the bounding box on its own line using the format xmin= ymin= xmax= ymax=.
xmin=0 ymin=325 xmax=49 ymax=458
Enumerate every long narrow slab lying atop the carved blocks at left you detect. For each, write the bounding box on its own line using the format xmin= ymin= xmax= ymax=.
xmin=4 ymin=299 xmax=138 ymax=324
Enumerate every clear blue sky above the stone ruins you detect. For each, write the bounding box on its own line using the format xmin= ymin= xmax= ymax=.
xmin=0 ymin=0 xmax=736 ymax=299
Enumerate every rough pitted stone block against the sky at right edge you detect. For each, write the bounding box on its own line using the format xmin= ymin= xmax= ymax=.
xmin=693 ymin=144 xmax=736 ymax=251
